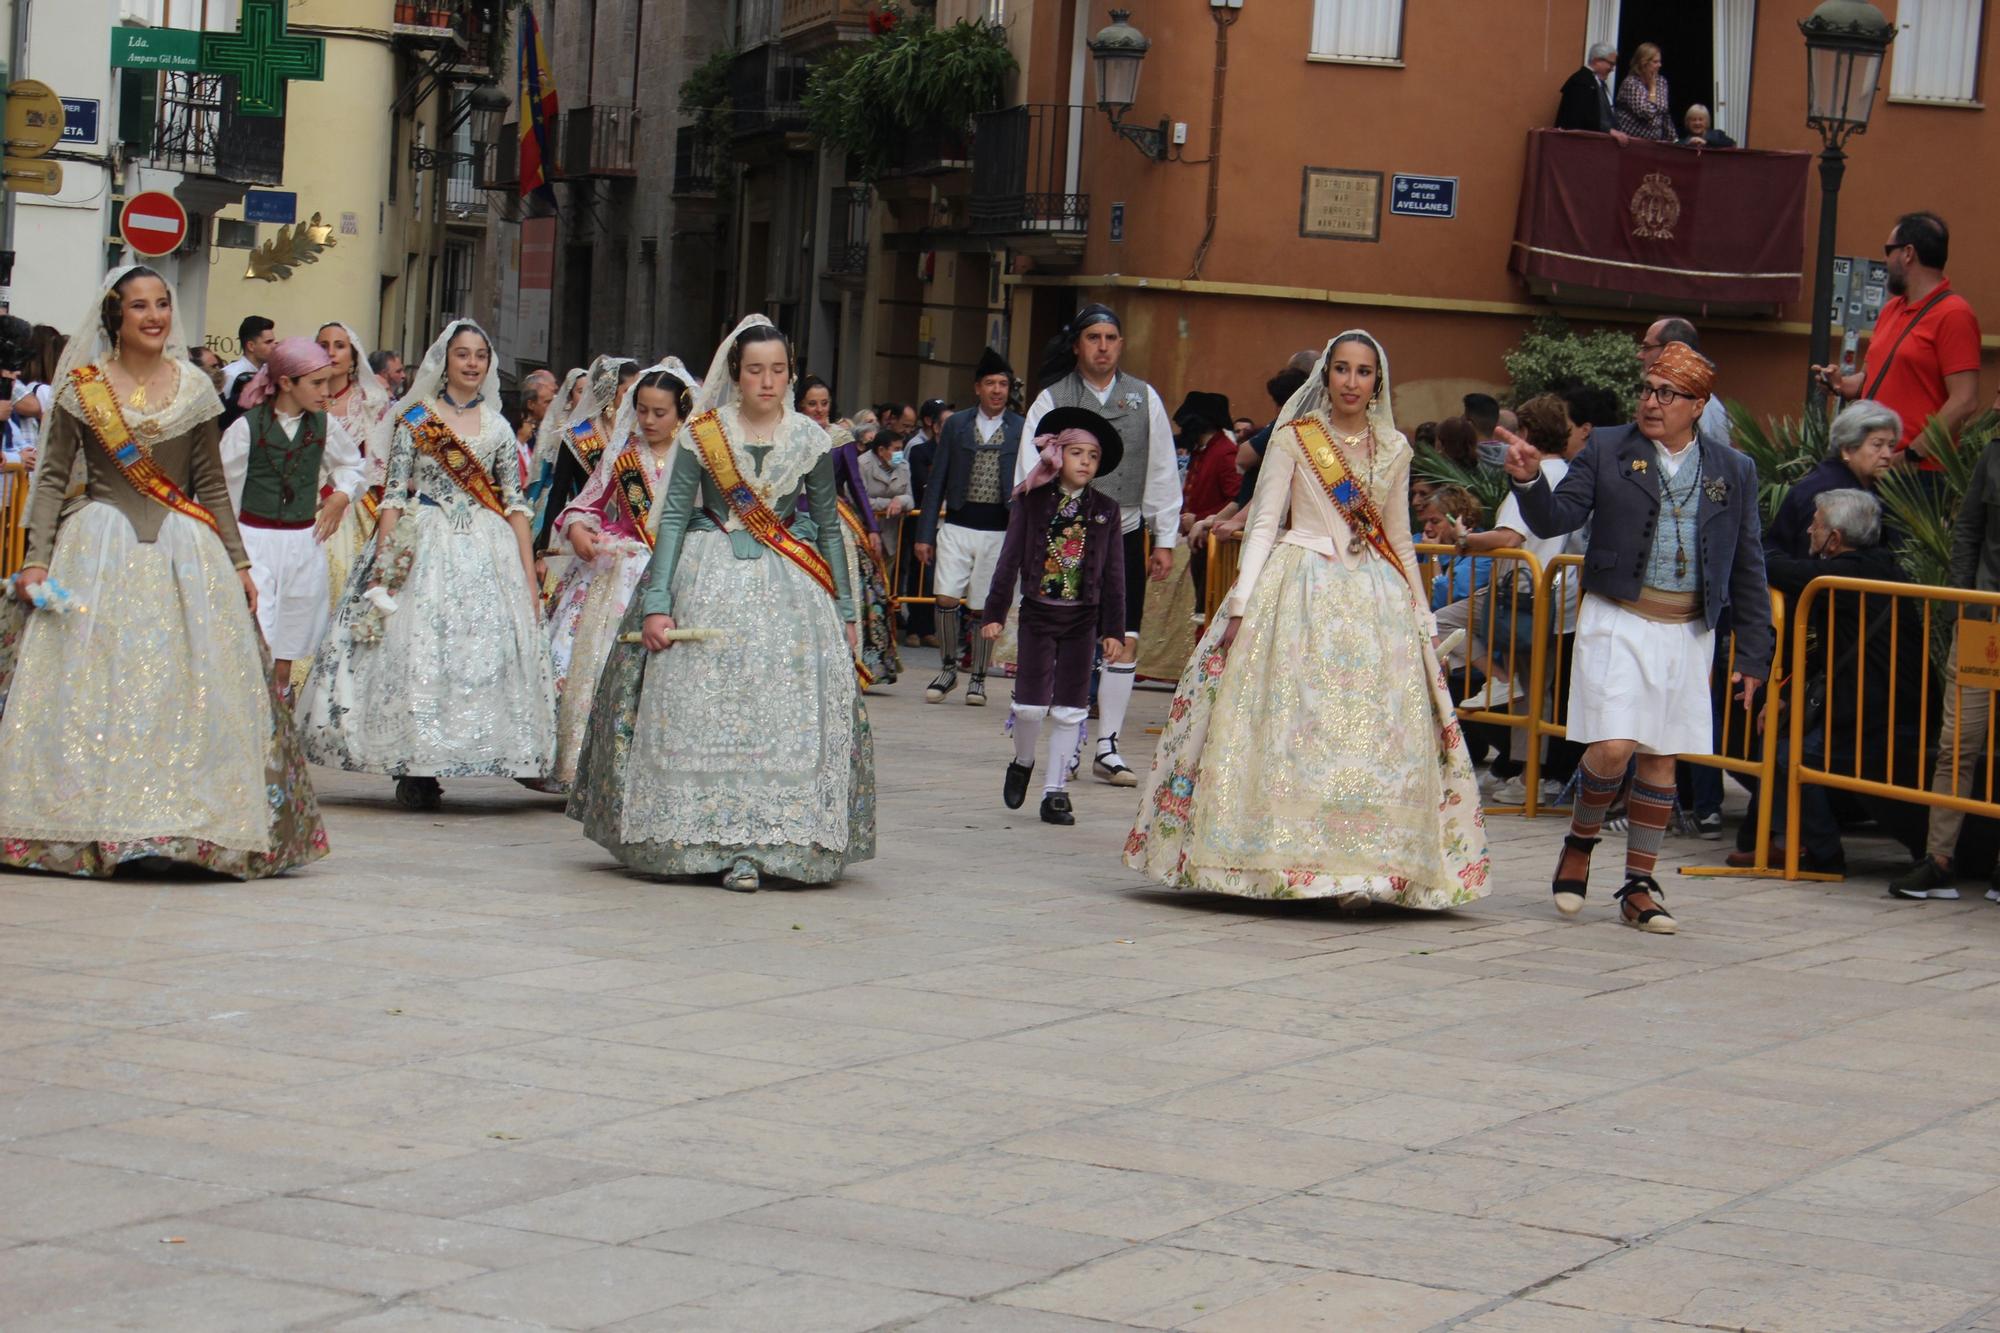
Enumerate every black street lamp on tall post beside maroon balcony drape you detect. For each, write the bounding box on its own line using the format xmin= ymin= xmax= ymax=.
xmin=1798 ymin=0 xmax=1896 ymax=410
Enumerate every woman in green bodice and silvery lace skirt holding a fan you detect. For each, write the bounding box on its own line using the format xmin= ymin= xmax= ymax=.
xmin=570 ymin=316 xmax=874 ymax=893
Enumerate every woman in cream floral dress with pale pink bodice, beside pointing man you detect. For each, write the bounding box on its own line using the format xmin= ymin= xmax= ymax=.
xmin=1124 ymin=330 xmax=1490 ymax=909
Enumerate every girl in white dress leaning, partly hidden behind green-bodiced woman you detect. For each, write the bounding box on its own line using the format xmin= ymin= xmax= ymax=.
xmin=530 ymin=356 xmax=694 ymax=793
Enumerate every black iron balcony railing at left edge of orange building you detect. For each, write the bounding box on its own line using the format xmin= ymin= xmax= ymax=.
xmin=968 ymin=102 xmax=1090 ymax=236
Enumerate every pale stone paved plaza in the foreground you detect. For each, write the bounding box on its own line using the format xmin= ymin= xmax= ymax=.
xmin=0 ymin=677 xmax=2000 ymax=1333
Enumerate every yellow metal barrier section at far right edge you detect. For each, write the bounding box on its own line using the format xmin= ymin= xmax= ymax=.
xmin=1784 ymin=574 xmax=2000 ymax=879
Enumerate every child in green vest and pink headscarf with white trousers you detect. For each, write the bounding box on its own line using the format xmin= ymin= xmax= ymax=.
xmin=222 ymin=338 xmax=362 ymax=691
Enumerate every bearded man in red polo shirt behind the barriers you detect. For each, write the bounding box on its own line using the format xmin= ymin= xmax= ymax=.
xmin=1814 ymin=212 xmax=1980 ymax=470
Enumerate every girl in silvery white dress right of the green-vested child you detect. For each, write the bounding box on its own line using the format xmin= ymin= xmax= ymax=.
xmin=298 ymin=320 xmax=556 ymax=811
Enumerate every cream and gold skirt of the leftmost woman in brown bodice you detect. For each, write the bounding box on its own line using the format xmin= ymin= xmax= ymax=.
xmin=0 ymin=504 xmax=326 ymax=879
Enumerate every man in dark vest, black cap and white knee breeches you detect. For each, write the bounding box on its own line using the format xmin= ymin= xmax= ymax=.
xmin=916 ymin=348 xmax=1022 ymax=707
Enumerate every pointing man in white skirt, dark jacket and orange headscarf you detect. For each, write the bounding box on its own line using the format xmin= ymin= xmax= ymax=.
xmin=1500 ymin=342 xmax=1772 ymax=935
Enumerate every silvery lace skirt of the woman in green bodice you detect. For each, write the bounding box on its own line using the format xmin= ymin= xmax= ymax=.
xmin=570 ymin=532 xmax=874 ymax=885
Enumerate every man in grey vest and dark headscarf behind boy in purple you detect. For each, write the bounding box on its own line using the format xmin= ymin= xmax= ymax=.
xmin=1014 ymin=304 xmax=1180 ymax=787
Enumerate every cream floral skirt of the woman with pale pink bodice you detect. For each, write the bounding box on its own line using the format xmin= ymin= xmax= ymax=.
xmin=1124 ymin=544 xmax=1490 ymax=911
